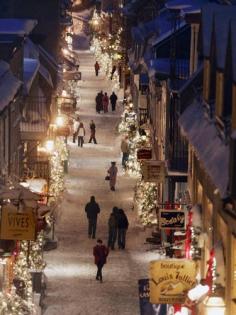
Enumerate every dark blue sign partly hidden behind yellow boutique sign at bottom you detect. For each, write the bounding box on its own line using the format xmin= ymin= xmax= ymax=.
xmin=138 ymin=279 xmax=168 ymax=315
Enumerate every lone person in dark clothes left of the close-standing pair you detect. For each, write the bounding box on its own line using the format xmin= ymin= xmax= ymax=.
xmin=85 ymin=196 xmax=100 ymax=238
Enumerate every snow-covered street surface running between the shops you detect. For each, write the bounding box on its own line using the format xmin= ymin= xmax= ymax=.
xmin=44 ymin=11 xmax=159 ymax=315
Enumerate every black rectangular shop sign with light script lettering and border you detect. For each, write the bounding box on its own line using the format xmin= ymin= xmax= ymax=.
xmin=159 ymin=209 xmax=186 ymax=230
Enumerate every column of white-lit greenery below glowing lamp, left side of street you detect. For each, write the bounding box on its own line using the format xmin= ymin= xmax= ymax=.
xmin=49 ymin=137 xmax=68 ymax=199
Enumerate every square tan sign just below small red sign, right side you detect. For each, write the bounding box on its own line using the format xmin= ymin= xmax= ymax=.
xmin=141 ymin=161 xmax=166 ymax=183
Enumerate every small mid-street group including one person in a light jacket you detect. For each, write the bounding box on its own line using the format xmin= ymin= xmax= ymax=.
xmin=73 ymin=118 xmax=97 ymax=148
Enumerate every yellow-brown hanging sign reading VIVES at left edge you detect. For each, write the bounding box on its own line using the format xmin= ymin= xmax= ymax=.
xmin=0 ymin=206 xmax=36 ymax=240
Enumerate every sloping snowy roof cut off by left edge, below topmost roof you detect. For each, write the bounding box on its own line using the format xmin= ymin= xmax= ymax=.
xmin=0 ymin=60 xmax=22 ymax=111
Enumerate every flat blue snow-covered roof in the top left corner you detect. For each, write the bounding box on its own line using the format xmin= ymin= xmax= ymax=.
xmin=0 ymin=19 xmax=37 ymax=36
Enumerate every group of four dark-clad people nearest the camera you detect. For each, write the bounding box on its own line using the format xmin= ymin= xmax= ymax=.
xmin=85 ymin=196 xmax=129 ymax=282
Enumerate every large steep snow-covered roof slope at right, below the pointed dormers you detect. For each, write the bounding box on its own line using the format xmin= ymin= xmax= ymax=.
xmin=179 ymin=100 xmax=229 ymax=198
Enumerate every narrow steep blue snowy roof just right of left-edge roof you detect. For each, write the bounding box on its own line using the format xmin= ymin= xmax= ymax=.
xmin=23 ymin=58 xmax=40 ymax=93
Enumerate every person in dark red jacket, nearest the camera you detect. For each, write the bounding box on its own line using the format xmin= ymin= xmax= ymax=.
xmin=93 ymin=239 xmax=109 ymax=282
